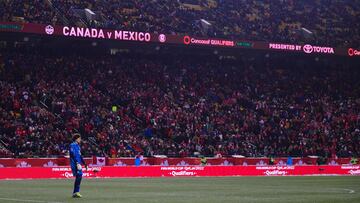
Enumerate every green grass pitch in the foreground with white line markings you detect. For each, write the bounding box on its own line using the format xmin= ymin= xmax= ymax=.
xmin=0 ymin=176 xmax=360 ymax=203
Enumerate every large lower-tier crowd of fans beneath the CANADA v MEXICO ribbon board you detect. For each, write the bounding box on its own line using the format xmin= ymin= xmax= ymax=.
xmin=0 ymin=47 xmax=360 ymax=157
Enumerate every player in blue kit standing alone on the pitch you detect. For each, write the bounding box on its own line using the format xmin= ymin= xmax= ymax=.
xmin=69 ymin=133 xmax=87 ymax=198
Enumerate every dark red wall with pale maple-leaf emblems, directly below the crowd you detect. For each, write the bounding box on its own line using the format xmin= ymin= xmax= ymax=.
xmin=0 ymin=157 xmax=350 ymax=168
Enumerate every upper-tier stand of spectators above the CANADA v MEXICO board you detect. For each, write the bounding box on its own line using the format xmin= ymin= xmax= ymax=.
xmin=0 ymin=0 xmax=360 ymax=47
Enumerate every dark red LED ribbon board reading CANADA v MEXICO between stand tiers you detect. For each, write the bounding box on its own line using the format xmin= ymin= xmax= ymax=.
xmin=0 ymin=22 xmax=360 ymax=57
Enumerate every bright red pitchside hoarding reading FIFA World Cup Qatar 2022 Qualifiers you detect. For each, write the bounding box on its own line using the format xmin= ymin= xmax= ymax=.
xmin=0 ymin=165 xmax=360 ymax=179
